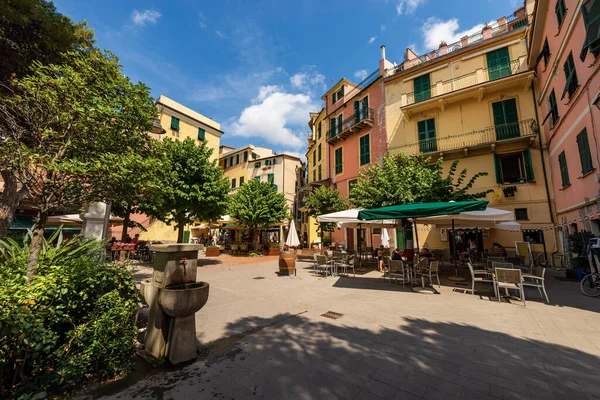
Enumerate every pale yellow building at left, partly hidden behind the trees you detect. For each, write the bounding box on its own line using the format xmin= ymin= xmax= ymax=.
xmin=137 ymin=95 xmax=223 ymax=242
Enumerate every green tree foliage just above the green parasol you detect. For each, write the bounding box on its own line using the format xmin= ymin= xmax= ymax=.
xmin=350 ymin=154 xmax=492 ymax=208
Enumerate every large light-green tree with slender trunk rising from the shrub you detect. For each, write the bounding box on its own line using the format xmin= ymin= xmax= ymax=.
xmin=0 ymin=49 xmax=157 ymax=281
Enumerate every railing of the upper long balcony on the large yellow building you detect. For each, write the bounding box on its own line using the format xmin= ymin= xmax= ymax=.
xmin=400 ymin=56 xmax=527 ymax=107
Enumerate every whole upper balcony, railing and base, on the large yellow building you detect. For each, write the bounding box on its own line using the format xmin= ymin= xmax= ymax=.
xmin=400 ymin=56 xmax=533 ymax=116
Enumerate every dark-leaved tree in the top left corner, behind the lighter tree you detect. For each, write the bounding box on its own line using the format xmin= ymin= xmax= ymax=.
xmin=0 ymin=0 xmax=94 ymax=237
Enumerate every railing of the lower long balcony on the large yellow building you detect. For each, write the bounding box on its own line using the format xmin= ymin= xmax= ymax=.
xmin=390 ymin=119 xmax=536 ymax=154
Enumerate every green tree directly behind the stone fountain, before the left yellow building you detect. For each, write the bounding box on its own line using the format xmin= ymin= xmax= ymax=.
xmin=152 ymin=138 xmax=229 ymax=243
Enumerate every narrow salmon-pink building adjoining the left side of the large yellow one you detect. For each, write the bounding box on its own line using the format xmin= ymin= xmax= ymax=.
xmin=322 ymin=52 xmax=387 ymax=249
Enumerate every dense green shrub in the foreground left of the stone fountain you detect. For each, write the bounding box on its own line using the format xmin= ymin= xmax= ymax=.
xmin=0 ymin=230 xmax=137 ymax=397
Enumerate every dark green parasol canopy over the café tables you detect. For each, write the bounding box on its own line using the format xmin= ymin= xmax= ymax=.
xmin=358 ymin=200 xmax=488 ymax=222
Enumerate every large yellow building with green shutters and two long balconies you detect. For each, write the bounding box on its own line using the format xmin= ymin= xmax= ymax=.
xmin=384 ymin=2 xmax=559 ymax=266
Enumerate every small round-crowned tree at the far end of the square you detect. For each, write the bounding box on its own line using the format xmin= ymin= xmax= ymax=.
xmin=229 ymin=179 xmax=288 ymax=250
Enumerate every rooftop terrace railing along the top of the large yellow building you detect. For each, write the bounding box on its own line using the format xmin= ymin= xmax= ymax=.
xmin=394 ymin=15 xmax=529 ymax=72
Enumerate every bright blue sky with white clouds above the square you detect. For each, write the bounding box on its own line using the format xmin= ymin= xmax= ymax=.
xmin=55 ymin=0 xmax=522 ymax=153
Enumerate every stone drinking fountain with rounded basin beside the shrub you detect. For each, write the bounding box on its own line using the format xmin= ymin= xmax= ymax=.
xmin=141 ymin=244 xmax=209 ymax=364
